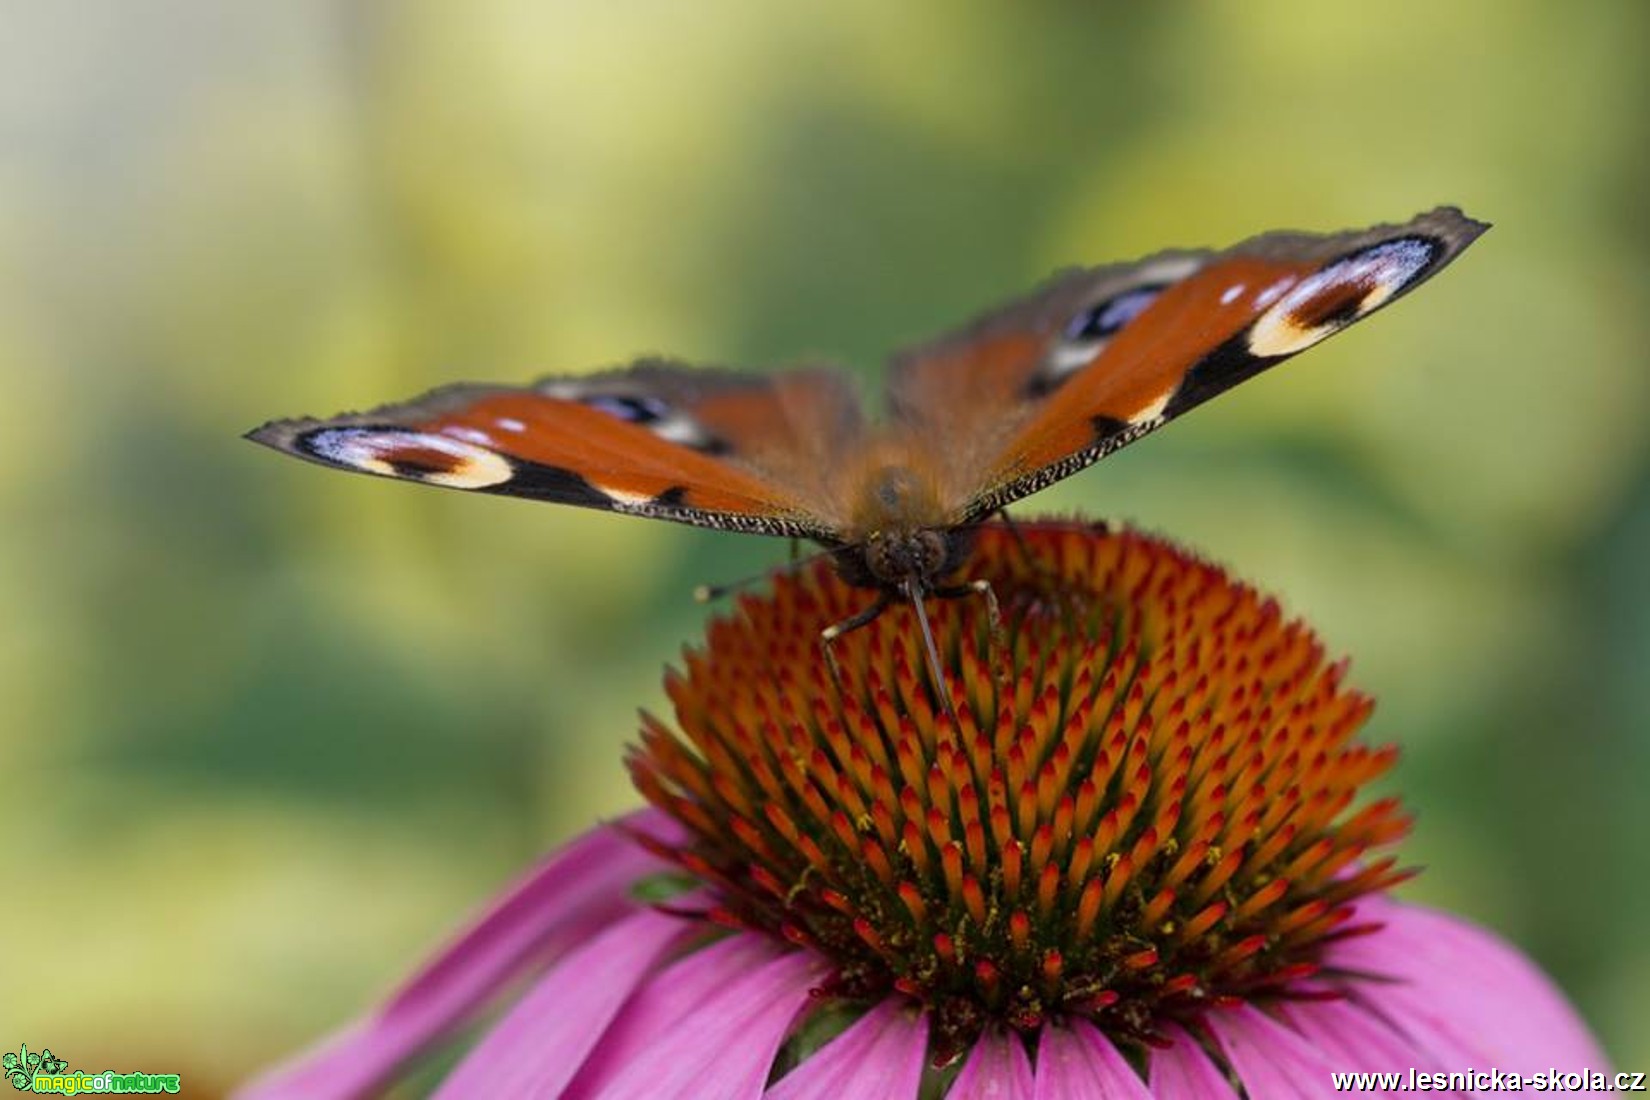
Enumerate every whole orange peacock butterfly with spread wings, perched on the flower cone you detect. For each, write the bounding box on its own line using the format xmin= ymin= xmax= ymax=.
xmin=251 ymin=206 xmax=1487 ymax=682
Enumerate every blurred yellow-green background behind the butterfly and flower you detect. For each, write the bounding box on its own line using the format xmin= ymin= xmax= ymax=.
xmin=0 ymin=0 xmax=1650 ymax=1095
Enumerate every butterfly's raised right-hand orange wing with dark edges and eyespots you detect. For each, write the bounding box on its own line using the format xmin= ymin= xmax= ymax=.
xmin=891 ymin=208 xmax=1488 ymax=523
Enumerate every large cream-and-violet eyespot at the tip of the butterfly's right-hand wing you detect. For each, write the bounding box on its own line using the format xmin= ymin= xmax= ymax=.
xmin=1249 ymin=237 xmax=1440 ymax=358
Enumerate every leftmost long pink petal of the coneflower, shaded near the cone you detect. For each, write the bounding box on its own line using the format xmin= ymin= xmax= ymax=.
xmin=238 ymin=810 xmax=678 ymax=1100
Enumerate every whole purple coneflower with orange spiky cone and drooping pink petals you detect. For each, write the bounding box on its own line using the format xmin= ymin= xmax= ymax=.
xmin=246 ymin=523 xmax=1607 ymax=1100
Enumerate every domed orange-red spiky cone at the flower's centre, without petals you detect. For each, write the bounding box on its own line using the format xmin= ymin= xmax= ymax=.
xmin=629 ymin=524 xmax=1409 ymax=1059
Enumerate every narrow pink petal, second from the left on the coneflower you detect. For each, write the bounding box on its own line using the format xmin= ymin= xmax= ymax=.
xmin=436 ymin=910 xmax=695 ymax=1100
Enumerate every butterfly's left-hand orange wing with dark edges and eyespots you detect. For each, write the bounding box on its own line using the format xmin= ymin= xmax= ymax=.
xmin=249 ymin=361 xmax=863 ymax=541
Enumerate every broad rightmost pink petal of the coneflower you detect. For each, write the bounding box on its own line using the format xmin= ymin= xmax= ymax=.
xmin=1328 ymin=899 xmax=1609 ymax=1074
